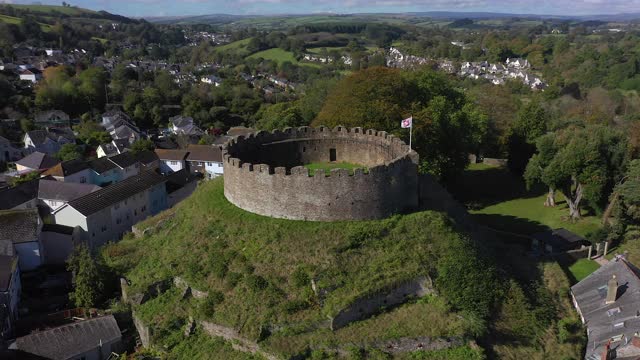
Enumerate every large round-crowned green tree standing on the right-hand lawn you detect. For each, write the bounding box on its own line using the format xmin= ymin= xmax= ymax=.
xmin=525 ymin=125 xmax=627 ymax=220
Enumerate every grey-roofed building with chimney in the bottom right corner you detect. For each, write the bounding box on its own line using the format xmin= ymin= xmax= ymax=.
xmin=571 ymin=255 xmax=640 ymax=360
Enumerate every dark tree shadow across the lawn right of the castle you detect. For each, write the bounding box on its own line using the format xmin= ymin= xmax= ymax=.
xmin=448 ymin=168 xmax=546 ymax=209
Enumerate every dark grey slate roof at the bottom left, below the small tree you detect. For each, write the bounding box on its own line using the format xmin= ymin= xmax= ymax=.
xmin=10 ymin=315 xmax=122 ymax=360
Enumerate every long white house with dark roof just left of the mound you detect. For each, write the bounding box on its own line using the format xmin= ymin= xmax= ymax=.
xmin=53 ymin=171 xmax=167 ymax=249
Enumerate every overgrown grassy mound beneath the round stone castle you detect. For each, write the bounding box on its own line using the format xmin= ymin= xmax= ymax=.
xmin=103 ymin=179 xmax=496 ymax=355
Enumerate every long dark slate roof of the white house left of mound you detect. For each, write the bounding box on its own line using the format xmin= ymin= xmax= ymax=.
xmin=67 ymin=170 xmax=166 ymax=216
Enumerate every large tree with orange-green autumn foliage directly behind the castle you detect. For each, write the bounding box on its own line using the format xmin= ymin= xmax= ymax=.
xmin=313 ymin=68 xmax=487 ymax=182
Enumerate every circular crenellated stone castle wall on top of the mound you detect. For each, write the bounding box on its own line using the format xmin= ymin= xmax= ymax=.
xmin=223 ymin=127 xmax=418 ymax=221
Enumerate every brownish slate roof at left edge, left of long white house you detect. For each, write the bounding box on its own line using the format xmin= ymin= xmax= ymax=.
xmin=0 ymin=209 xmax=40 ymax=244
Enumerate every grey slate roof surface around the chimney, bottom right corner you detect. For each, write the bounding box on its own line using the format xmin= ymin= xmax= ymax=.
xmin=571 ymin=257 xmax=640 ymax=359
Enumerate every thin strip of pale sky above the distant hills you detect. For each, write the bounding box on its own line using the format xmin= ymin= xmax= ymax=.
xmin=5 ymin=0 xmax=640 ymax=17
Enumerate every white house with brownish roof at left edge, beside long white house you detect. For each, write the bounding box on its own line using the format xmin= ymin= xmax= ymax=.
xmin=0 ymin=209 xmax=42 ymax=271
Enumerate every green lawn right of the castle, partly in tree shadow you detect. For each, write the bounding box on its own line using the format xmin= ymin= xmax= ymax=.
xmin=451 ymin=164 xmax=600 ymax=236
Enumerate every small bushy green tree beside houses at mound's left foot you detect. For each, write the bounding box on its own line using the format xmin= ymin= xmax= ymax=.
xmin=67 ymin=244 xmax=104 ymax=308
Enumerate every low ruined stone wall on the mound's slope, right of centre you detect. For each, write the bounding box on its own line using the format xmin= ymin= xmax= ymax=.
xmin=331 ymin=276 xmax=433 ymax=330
